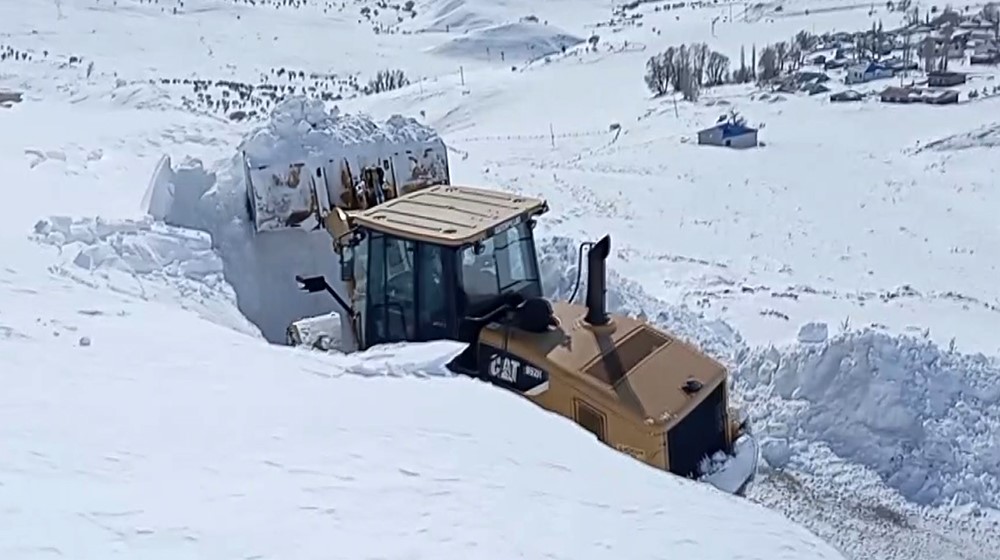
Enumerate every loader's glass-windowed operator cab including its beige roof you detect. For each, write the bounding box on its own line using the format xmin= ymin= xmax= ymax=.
xmin=340 ymin=185 xmax=547 ymax=349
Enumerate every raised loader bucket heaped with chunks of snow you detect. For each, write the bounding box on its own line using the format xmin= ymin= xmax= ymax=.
xmin=239 ymin=97 xmax=450 ymax=231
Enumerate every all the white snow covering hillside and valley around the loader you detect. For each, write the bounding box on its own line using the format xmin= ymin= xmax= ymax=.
xmin=0 ymin=0 xmax=1000 ymax=560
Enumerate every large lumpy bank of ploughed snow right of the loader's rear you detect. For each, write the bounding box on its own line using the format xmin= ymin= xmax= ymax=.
xmin=737 ymin=331 xmax=1000 ymax=507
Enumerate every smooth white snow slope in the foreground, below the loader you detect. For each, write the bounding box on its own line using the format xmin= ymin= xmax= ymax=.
xmin=0 ymin=294 xmax=842 ymax=560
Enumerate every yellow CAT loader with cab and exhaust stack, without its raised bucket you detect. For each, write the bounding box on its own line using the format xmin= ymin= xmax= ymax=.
xmin=248 ymin=139 xmax=759 ymax=495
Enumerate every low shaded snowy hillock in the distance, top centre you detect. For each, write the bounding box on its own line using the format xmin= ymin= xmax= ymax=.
xmin=431 ymin=22 xmax=583 ymax=62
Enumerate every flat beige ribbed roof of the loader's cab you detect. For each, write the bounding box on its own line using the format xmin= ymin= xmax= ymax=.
xmin=352 ymin=185 xmax=548 ymax=246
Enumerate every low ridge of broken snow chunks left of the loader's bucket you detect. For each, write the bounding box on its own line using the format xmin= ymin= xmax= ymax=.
xmin=34 ymin=216 xmax=260 ymax=336
